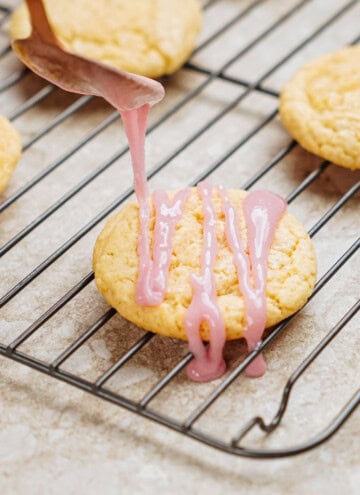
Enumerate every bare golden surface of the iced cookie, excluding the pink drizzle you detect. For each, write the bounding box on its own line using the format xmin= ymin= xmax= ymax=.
xmin=93 ymin=189 xmax=316 ymax=340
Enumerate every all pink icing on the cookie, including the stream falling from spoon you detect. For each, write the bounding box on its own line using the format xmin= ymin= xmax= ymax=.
xmin=121 ymin=105 xmax=286 ymax=381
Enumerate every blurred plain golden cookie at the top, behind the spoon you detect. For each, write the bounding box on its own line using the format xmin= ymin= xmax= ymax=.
xmin=10 ymin=0 xmax=202 ymax=78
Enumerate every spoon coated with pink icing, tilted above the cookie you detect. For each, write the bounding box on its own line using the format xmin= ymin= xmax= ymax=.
xmin=12 ymin=0 xmax=165 ymax=112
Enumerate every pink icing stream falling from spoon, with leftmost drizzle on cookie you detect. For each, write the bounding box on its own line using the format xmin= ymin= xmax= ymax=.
xmin=121 ymin=105 xmax=190 ymax=306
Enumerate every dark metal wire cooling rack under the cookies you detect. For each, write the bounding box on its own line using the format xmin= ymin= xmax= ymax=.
xmin=0 ymin=0 xmax=360 ymax=458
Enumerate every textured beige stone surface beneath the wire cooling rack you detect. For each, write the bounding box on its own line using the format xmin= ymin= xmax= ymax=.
xmin=0 ymin=0 xmax=360 ymax=495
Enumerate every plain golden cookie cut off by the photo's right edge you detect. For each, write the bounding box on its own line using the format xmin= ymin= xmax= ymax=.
xmin=280 ymin=45 xmax=360 ymax=169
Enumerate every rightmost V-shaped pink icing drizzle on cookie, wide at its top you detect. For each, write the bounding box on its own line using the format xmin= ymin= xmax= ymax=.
xmin=220 ymin=187 xmax=286 ymax=377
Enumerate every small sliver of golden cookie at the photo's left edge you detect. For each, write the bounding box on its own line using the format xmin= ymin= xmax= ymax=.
xmin=0 ymin=116 xmax=21 ymax=193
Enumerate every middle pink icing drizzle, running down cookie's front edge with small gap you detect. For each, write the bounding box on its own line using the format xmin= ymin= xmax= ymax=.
xmin=185 ymin=182 xmax=226 ymax=382
